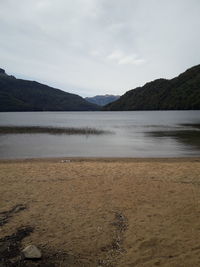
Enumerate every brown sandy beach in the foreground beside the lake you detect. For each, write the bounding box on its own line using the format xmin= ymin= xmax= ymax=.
xmin=0 ymin=158 xmax=200 ymax=267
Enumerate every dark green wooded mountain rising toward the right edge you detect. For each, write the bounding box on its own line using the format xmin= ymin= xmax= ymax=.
xmin=103 ymin=65 xmax=200 ymax=110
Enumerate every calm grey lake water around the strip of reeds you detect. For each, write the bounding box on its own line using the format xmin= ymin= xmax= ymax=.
xmin=0 ymin=111 xmax=200 ymax=159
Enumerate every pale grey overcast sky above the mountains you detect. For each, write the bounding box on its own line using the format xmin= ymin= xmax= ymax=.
xmin=0 ymin=0 xmax=200 ymax=96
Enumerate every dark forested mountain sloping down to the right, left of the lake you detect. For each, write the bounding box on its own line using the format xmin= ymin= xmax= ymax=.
xmin=0 ymin=69 xmax=100 ymax=111
